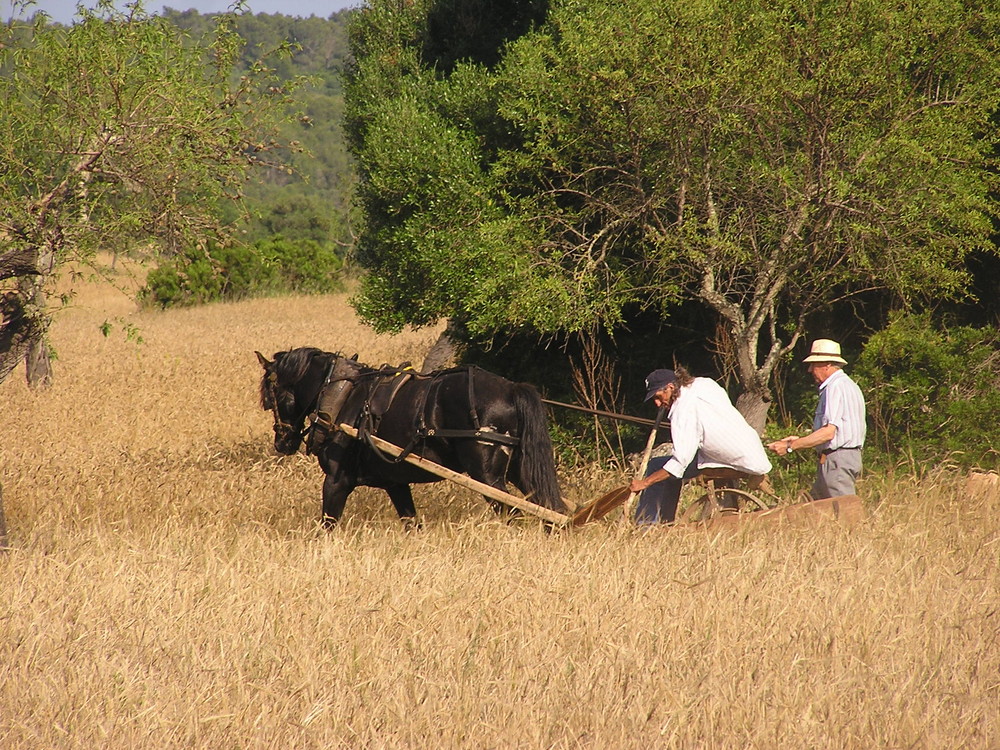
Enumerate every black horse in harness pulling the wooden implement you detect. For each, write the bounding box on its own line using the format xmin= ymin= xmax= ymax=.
xmin=256 ymin=347 xmax=566 ymax=527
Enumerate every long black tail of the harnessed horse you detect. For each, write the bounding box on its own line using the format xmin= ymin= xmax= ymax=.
xmin=514 ymin=383 xmax=567 ymax=513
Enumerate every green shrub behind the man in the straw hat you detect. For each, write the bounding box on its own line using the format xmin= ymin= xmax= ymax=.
xmin=856 ymin=314 xmax=1000 ymax=466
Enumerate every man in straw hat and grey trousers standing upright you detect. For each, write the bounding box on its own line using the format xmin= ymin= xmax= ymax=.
xmin=767 ymin=339 xmax=865 ymax=500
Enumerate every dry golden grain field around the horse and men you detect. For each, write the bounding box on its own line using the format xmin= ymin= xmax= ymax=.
xmin=0 ymin=268 xmax=1000 ymax=750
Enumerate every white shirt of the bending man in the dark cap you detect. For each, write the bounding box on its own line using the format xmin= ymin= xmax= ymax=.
xmin=663 ymin=378 xmax=771 ymax=477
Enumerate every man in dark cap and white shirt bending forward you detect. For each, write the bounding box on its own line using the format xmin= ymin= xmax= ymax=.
xmin=630 ymin=367 xmax=771 ymax=524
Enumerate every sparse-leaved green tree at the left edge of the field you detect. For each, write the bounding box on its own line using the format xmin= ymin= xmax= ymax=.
xmin=0 ymin=1 xmax=297 ymax=384
